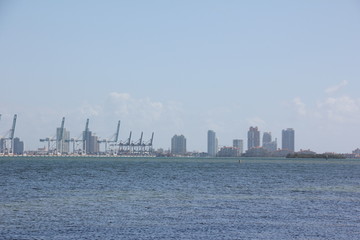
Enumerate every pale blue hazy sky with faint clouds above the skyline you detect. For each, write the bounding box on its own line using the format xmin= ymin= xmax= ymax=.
xmin=0 ymin=0 xmax=360 ymax=153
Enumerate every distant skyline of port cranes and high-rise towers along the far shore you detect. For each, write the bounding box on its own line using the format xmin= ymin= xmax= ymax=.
xmin=0 ymin=114 xmax=295 ymax=157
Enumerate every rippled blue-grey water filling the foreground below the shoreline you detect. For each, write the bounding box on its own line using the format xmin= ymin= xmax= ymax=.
xmin=0 ymin=158 xmax=360 ymax=239
